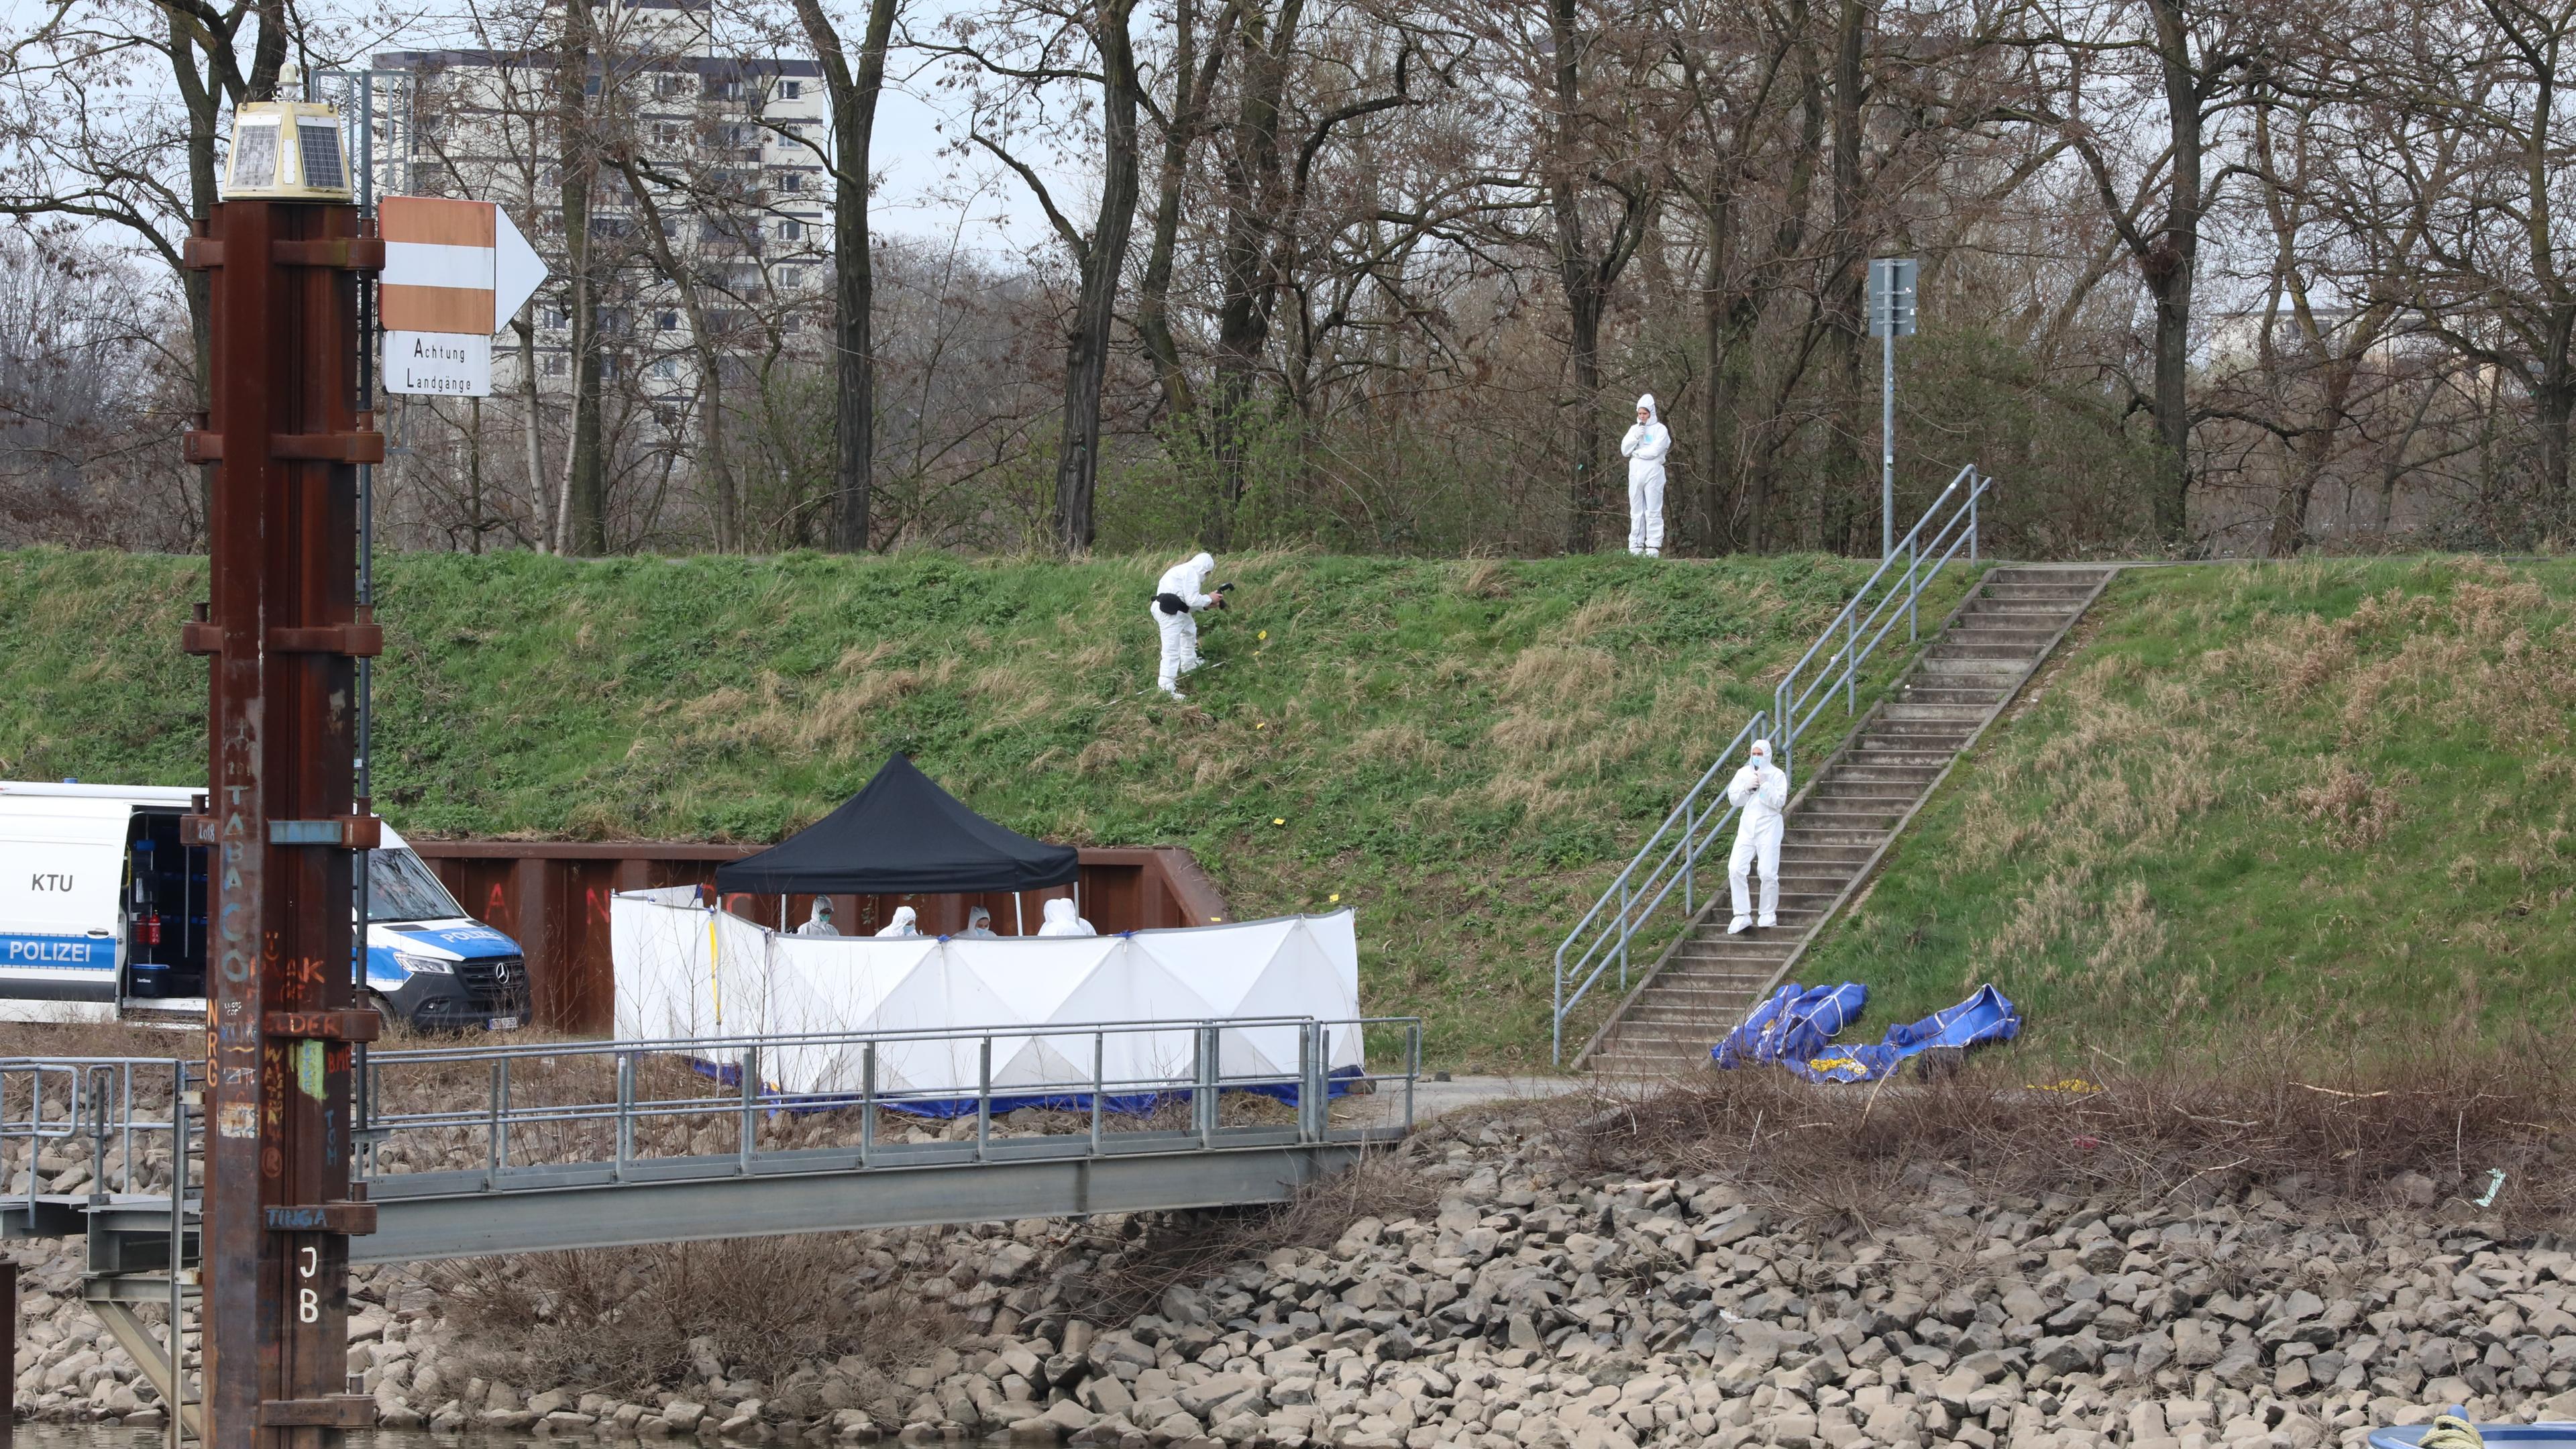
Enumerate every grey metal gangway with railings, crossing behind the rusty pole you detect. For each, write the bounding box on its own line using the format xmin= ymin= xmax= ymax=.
xmin=0 ymin=1016 xmax=1422 ymax=1273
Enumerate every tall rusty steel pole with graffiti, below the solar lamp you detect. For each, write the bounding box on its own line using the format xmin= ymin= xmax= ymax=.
xmin=185 ymin=201 xmax=384 ymax=1449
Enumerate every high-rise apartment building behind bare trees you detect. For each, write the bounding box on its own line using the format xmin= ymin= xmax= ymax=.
xmin=371 ymin=0 xmax=832 ymax=399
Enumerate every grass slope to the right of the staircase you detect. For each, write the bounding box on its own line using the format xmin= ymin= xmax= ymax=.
xmin=1798 ymin=559 xmax=2576 ymax=1073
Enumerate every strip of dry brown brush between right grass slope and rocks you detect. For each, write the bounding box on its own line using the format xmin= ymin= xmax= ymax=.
xmin=1556 ymin=1042 xmax=2576 ymax=1230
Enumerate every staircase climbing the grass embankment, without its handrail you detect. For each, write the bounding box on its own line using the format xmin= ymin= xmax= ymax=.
xmin=1576 ymin=565 xmax=2117 ymax=1078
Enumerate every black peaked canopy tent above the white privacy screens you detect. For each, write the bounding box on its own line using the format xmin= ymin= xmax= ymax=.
xmin=716 ymin=755 xmax=1082 ymax=895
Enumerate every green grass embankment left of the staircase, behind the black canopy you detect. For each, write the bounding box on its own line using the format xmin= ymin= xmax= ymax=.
xmin=0 ymin=541 xmax=1966 ymax=1065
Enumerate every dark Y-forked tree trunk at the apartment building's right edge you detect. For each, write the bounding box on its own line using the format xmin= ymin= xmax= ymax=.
xmin=796 ymin=0 xmax=896 ymax=554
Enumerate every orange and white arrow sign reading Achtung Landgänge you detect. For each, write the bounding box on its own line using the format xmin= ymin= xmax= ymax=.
xmin=376 ymin=196 xmax=546 ymax=397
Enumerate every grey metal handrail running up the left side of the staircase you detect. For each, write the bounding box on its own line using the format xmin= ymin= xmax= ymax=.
xmin=1548 ymin=464 xmax=1994 ymax=1065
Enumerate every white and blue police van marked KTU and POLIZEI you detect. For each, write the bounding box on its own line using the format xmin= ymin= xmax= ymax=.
xmin=0 ymin=782 xmax=528 ymax=1031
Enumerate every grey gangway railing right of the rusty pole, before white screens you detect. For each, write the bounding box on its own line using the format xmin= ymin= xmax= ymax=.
xmin=356 ymin=1016 xmax=1422 ymax=1201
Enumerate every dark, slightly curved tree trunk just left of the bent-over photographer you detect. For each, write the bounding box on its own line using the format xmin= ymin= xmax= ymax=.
xmin=1056 ymin=0 xmax=1138 ymax=554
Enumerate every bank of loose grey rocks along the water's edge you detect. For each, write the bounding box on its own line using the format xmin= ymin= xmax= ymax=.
xmin=18 ymin=1087 xmax=2576 ymax=1449
